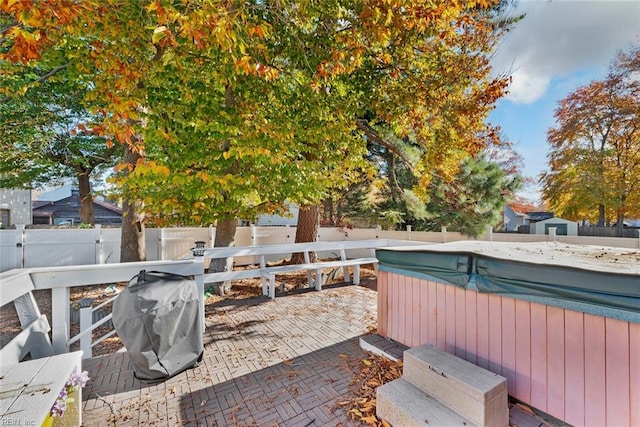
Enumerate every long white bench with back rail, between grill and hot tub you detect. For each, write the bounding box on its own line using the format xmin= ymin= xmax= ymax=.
xmin=202 ymin=239 xmax=399 ymax=299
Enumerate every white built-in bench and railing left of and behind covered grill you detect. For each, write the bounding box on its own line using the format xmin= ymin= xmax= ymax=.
xmin=0 ymin=260 xmax=204 ymax=426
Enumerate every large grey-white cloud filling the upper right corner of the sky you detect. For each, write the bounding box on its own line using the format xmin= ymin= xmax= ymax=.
xmin=492 ymin=1 xmax=640 ymax=103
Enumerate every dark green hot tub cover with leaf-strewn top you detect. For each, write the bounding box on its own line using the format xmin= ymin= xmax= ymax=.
xmin=376 ymin=241 xmax=640 ymax=313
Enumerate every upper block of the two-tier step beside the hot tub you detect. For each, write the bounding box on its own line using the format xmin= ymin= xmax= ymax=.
xmin=403 ymin=344 xmax=509 ymax=427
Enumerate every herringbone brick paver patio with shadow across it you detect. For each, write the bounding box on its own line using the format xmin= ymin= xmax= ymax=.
xmin=83 ymin=285 xmax=376 ymax=426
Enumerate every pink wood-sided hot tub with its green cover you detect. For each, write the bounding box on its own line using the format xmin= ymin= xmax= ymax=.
xmin=376 ymin=241 xmax=640 ymax=426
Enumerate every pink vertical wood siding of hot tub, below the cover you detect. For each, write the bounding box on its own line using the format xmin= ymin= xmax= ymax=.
xmin=378 ymin=271 xmax=640 ymax=426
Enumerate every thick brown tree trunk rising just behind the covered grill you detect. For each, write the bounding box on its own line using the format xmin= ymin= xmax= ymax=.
xmin=120 ymin=146 xmax=147 ymax=262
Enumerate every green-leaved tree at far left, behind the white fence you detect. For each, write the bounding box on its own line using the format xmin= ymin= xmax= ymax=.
xmin=0 ymin=62 xmax=122 ymax=224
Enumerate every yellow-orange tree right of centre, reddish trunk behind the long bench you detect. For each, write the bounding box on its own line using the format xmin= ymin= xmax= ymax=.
xmin=296 ymin=1 xmax=508 ymax=247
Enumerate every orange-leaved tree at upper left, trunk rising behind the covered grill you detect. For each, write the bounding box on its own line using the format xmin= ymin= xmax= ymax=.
xmin=0 ymin=0 xmax=153 ymax=261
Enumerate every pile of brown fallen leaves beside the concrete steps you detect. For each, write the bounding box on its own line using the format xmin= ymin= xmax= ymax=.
xmin=337 ymin=354 xmax=402 ymax=427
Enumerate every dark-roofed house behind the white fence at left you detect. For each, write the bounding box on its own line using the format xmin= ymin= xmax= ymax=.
xmin=33 ymin=186 xmax=122 ymax=225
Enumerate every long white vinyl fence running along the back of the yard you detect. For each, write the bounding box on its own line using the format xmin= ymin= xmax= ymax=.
xmin=0 ymin=222 xmax=640 ymax=271
